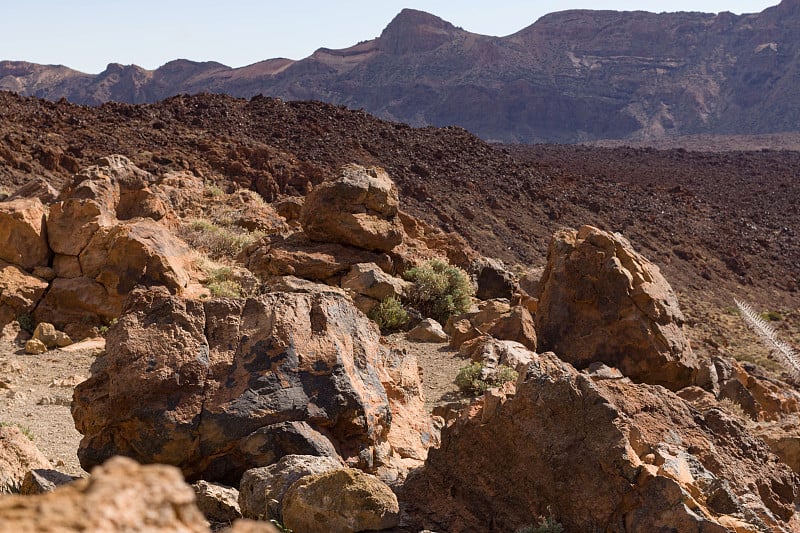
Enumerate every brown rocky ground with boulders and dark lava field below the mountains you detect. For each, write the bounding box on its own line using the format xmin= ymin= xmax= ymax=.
xmin=0 ymin=89 xmax=800 ymax=533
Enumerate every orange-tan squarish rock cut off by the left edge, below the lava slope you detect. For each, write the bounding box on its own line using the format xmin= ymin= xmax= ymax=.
xmin=0 ymin=198 xmax=51 ymax=270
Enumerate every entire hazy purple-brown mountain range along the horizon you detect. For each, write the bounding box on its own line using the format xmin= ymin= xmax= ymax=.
xmin=0 ymin=0 xmax=800 ymax=142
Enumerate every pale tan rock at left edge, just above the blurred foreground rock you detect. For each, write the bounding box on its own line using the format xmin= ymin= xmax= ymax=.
xmin=0 ymin=425 xmax=50 ymax=494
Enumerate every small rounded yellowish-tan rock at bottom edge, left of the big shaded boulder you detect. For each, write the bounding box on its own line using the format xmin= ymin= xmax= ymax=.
xmin=282 ymin=469 xmax=400 ymax=533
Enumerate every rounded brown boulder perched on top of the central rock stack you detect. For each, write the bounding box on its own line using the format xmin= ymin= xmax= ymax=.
xmin=300 ymin=165 xmax=403 ymax=252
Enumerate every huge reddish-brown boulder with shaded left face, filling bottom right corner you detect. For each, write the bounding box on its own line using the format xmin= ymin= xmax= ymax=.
xmin=402 ymin=353 xmax=800 ymax=533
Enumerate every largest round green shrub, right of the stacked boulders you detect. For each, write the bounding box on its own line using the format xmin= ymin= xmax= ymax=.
xmin=403 ymin=259 xmax=475 ymax=324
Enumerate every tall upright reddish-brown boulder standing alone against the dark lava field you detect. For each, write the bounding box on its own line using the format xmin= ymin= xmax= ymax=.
xmin=535 ymin=222 xmax=700 ymax=390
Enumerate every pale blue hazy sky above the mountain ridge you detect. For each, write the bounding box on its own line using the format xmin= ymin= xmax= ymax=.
xmin=0 ymin=0 xmax=779 ymax=73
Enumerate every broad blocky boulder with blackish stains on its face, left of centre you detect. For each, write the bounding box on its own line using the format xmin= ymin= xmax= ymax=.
xmin=72 ymin=289 xmax=428 ymax=485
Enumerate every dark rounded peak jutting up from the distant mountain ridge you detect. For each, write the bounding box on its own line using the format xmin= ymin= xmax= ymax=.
xmin=379 ymin=9 xmax=463 ymax=55
